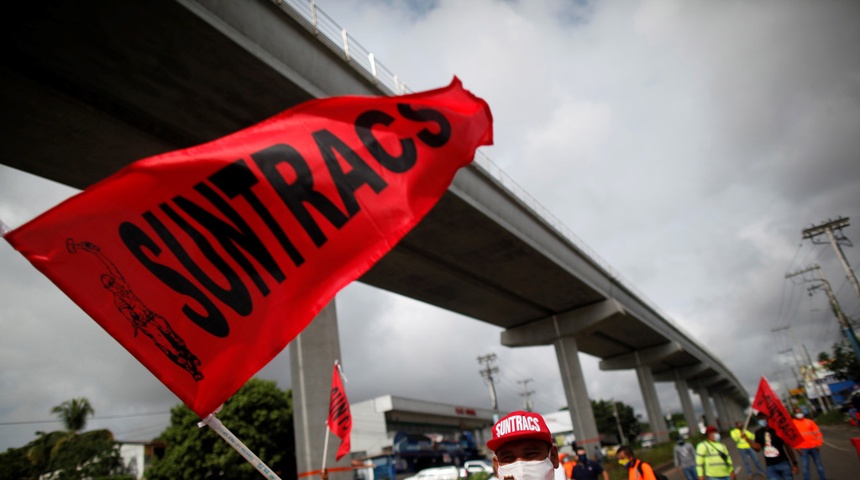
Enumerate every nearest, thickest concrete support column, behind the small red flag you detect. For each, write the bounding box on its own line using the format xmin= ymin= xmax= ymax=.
xmin=290 ymin=300 xmax=352 ymax=480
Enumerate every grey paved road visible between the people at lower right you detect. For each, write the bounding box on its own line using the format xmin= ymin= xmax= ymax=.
xmin=663 ymin=424 xmax=860 ymax=480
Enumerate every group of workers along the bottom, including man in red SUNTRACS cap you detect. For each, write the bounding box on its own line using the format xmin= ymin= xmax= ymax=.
xmin=474 ymin=408 xmax=826 ymax=480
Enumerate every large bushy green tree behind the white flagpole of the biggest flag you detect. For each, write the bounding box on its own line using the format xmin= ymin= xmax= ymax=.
xmin=146 ymin=379 xmax=298 ymax=480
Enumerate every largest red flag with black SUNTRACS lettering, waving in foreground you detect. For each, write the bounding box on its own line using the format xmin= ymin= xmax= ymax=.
xmin=6 ymin=78 xmax=492 ymax=417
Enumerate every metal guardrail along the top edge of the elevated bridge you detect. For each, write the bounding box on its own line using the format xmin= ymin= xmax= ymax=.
xmin=272 ymin=0 xmax=740 ymax=392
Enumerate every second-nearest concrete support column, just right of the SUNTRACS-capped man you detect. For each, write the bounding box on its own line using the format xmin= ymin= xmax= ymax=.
xmin=553 ymin=336 xmax=600 ymax=452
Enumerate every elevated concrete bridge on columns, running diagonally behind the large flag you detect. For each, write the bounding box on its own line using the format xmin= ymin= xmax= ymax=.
xmin=0 ymin=0 xmax=749 ymax=471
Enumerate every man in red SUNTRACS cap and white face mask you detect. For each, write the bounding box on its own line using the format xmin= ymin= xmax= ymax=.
xmin=487 ymin=411 xmax=558 ymax=480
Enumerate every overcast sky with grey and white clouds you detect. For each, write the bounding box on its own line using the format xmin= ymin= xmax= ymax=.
xmin=0 ymin=0 xmax=860 ymax=451
